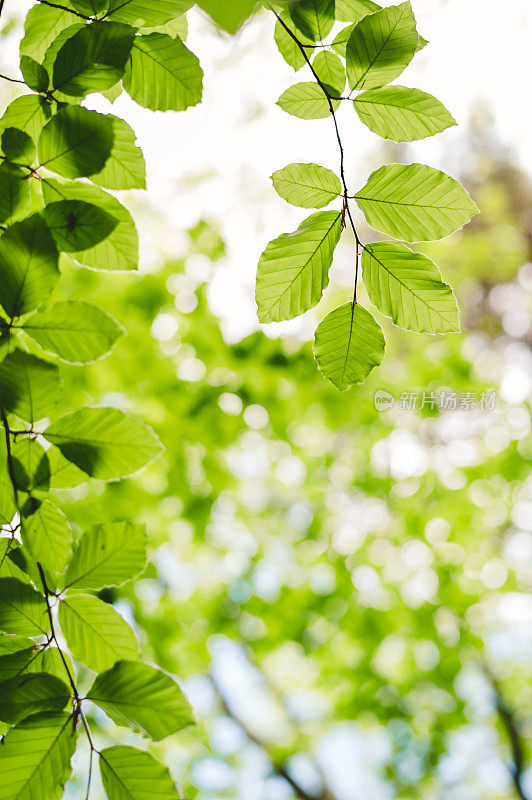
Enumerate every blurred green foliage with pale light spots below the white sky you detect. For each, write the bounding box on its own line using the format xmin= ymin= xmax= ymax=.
xmin=50 ymin=131 xmax=532 ymax=800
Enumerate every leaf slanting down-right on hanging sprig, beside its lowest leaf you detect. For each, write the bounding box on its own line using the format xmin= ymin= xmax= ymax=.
xmin=362 ymin=242 xmax=460 ymax=333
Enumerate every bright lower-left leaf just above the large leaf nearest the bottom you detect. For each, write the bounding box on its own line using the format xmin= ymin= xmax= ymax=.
xmin=59 ymin=594 xmax=139 ymax=672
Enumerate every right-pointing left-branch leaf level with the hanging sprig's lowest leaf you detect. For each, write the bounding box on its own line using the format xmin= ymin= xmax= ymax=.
xmin=23 ymin=300 xmax=123 ymax=364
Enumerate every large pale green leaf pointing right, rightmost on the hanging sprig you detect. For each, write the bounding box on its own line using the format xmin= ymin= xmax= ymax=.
xmin=355 ymin=164 xmax=478 ymax=242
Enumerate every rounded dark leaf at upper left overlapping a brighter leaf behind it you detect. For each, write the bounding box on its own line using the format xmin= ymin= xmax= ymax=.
xmin=39 ymin=106 xmax=113 ymax=178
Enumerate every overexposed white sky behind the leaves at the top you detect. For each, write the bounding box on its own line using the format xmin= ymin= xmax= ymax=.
xmin=1 ymin=0 xmax=532 ymax=338
